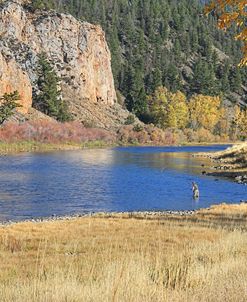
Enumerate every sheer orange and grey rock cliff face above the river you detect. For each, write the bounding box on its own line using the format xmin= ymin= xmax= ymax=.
xmin=0 ymin=0 xmax=127 ymax=127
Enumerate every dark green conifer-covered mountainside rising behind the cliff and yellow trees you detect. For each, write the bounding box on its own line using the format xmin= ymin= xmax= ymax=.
xmin=43 ymin=0 xmax=247 ymax=116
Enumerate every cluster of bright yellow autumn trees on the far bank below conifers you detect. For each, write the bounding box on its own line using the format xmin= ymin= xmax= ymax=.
xmin=148 ymin=87 xmax=244 ymax=142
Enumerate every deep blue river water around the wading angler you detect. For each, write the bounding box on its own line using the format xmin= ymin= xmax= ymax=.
xmin=0 ymin=145 xmax=247 ymax=221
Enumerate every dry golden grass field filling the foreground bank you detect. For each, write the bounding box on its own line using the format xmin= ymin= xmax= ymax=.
xmin=0 ymin=205 xmax=247 ymax=302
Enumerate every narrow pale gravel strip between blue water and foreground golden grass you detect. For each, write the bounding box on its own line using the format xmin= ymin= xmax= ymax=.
xmin=0 ymin=210 xmax=196 ymax=227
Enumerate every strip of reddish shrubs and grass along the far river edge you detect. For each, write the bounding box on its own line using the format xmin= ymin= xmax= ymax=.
xmin=0 ymin=119 xmax=239 ymax=154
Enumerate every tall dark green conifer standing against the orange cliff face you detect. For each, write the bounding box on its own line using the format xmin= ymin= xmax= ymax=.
xmin=33 ymin=53 xmax=71 ymax=122
